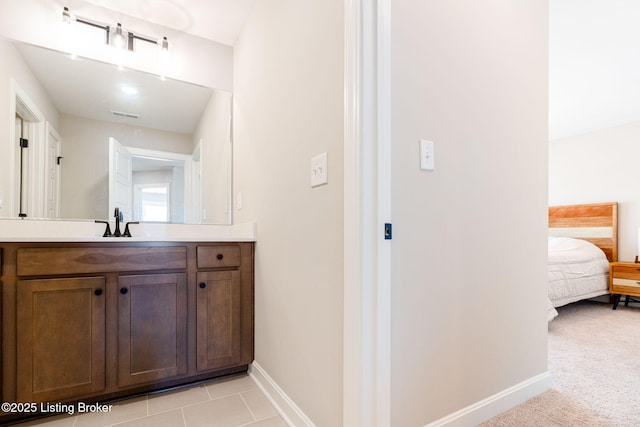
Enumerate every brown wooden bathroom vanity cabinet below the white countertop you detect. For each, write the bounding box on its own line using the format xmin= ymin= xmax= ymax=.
xmin=0 ymin=239 xmax=254 ymax=424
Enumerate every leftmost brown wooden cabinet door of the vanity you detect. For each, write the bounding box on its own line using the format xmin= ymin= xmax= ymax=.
xmin=16 ymin=277 xmax=105 ymax=402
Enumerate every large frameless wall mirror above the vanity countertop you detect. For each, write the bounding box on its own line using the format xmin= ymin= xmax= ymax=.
xmin=0 ymin=39 xmax=232 ymax=224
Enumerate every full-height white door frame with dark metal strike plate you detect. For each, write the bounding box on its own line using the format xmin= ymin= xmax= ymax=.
xmin=343 ymin=0 xmax=391 ymax=427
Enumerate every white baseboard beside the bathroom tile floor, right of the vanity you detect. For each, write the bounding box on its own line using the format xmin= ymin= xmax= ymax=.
xmin=249 ymin=361 xmax=315 ymax=427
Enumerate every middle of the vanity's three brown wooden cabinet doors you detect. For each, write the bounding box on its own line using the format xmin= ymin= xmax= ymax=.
xmin=118 ymin=274 xmax=187 ymax=387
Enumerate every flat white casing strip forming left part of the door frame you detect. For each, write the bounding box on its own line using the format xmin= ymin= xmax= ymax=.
xmin=342 ymin=0 xmax=375 ymax=427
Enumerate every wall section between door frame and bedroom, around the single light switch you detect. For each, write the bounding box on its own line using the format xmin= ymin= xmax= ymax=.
xmin=391 ymin=0 xmax=548 ymax=427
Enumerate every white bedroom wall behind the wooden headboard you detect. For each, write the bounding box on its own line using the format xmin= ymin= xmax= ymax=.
xmin=549 ymin=122 xmax=640 ymax=261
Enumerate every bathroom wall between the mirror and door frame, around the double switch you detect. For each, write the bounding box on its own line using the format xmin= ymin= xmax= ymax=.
xmin=234 ymin=0 xmax=344 ymax=427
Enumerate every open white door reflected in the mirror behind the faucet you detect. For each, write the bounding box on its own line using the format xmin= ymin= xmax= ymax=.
xmin=109 ymin=138 xmax=133 ymax=221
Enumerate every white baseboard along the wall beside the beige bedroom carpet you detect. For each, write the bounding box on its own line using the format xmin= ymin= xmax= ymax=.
xmin=425 ymin=371 xmax=552 ymax=427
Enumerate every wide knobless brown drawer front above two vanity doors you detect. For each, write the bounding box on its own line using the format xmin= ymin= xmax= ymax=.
xmin=16 ymin=246 xmax=187 ymax=276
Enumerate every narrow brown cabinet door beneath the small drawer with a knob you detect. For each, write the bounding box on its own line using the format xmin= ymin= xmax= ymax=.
xmin=196 ymin=270 xmax=242 ymax=371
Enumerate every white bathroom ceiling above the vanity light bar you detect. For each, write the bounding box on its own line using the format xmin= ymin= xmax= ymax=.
xmin=84 ymin=0 xmax=255 ymax=46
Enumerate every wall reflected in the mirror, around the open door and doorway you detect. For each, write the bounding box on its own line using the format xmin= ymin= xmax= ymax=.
xmin=58 ymin=114 xmax=192 ymax=220
